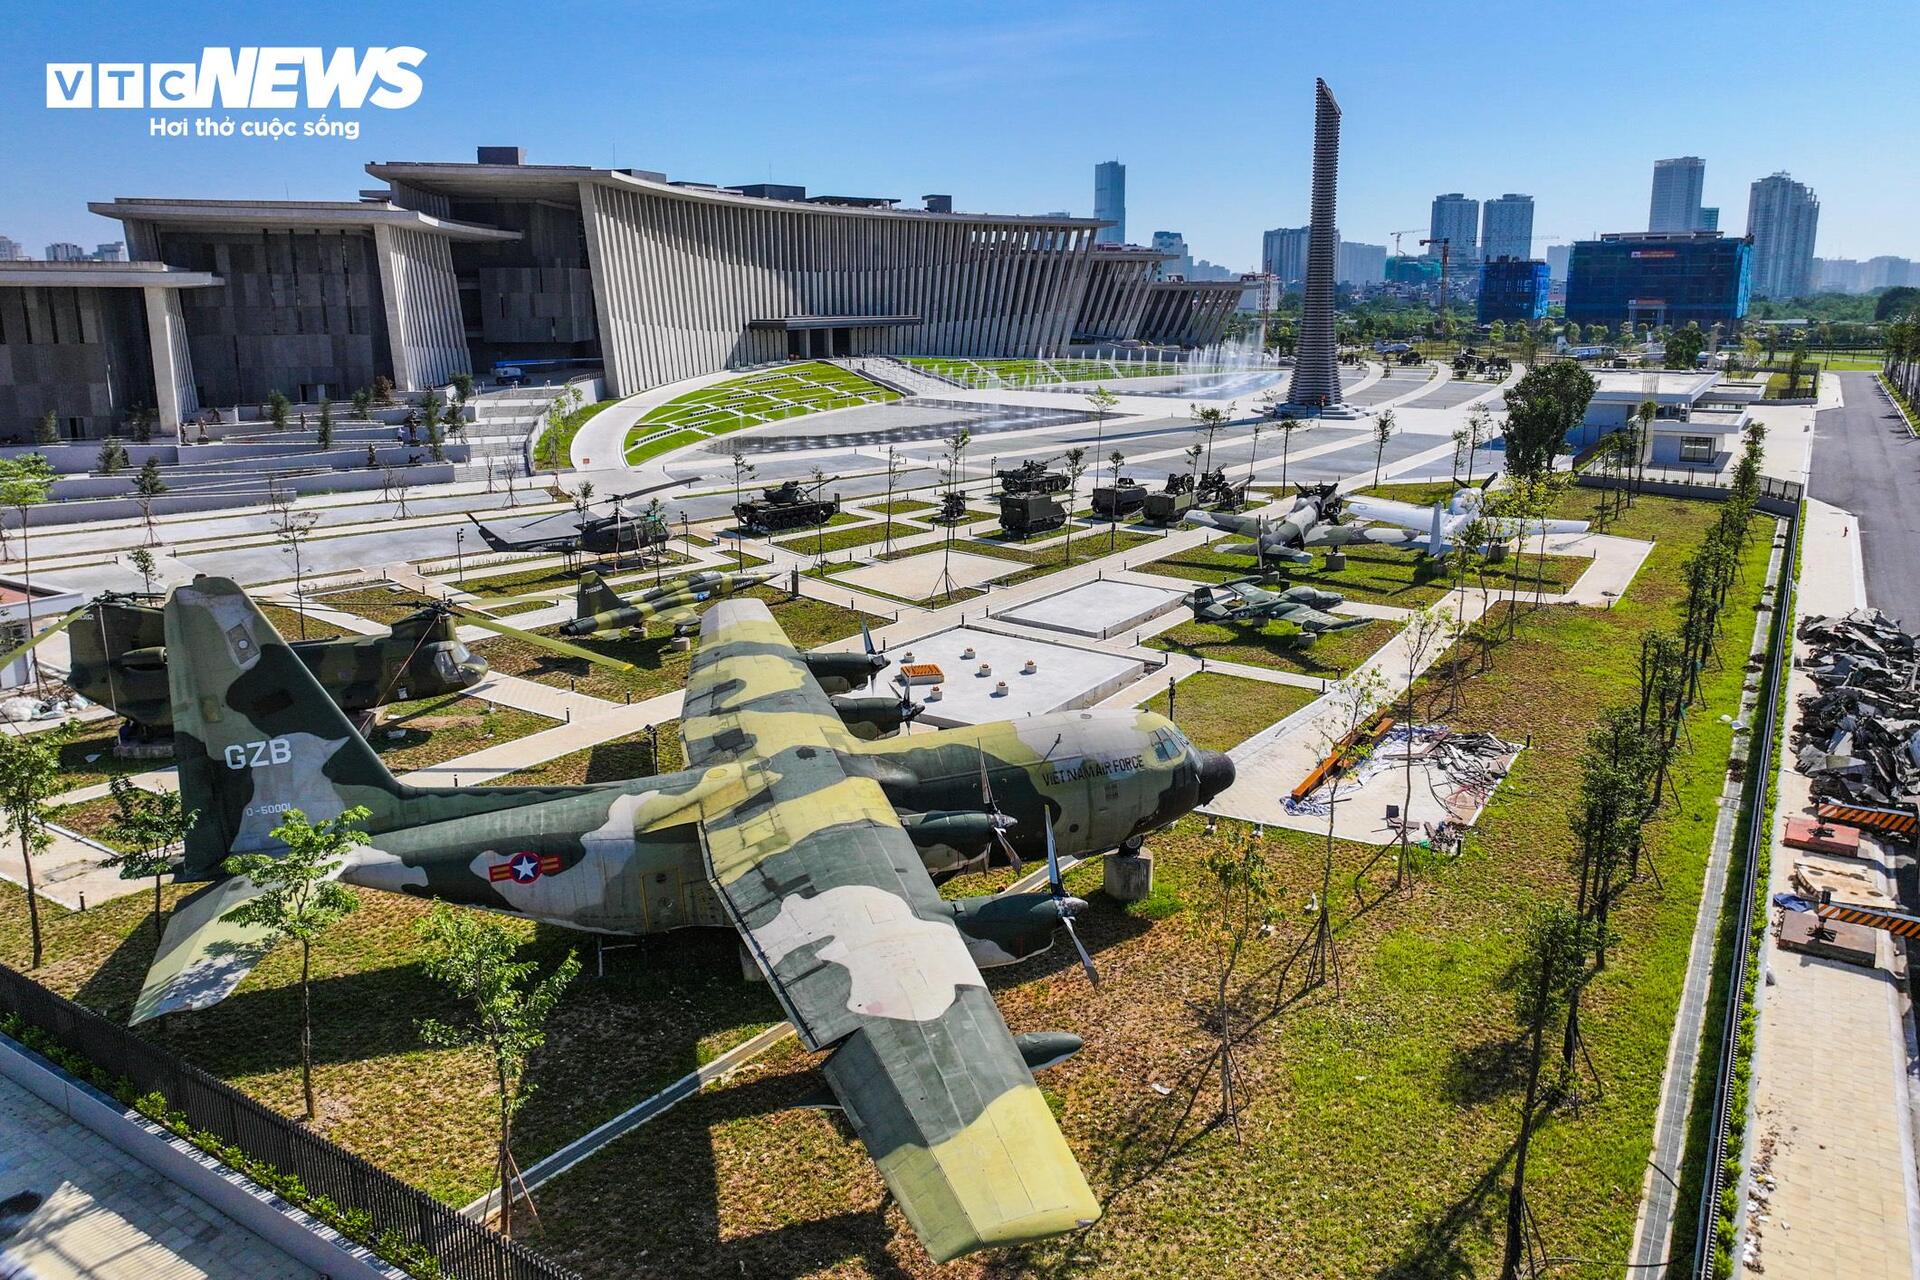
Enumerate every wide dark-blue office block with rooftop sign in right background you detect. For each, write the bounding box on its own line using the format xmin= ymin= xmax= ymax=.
xmin=1567 ymin=230 xmax=1753 ymax=328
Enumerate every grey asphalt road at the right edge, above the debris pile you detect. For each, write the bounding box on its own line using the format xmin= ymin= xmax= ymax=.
xmin=1811 ymin=372 xmax=1920 ymax=626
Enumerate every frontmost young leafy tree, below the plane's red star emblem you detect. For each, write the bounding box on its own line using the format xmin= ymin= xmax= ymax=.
xmin=419 ymin=902 xmax=580 ymax=1236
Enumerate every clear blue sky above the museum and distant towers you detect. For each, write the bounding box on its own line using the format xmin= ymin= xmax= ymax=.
xmin=0 ymin=0 xmax=1920 ymax=269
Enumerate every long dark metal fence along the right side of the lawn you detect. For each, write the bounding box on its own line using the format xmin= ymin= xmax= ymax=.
xmin=1693 ymin=498 xmax=1801 ymax=1280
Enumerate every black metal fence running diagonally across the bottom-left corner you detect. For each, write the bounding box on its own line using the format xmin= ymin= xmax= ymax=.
xmin=0 ymin=965 xmax=578 ymax=1280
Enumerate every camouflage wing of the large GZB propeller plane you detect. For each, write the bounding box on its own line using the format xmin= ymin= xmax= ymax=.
xmin=682 ymin=599 xmax=1100 ymax=1261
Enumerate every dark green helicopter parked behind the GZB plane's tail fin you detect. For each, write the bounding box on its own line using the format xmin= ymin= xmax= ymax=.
xmin=0 ymin=591 xmax=632 ymax=743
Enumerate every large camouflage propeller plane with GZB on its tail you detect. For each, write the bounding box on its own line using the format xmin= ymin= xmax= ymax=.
xmin=134 ymin=578 xmax=1233 ymax=1261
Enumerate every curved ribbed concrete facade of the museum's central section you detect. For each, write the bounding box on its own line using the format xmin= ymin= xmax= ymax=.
xmin=580 ymin=182 xmax=1092 ymax=395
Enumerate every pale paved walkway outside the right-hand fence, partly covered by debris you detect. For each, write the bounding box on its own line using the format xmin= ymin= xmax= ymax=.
xmin=1741 ymin=501 xmax=1920 ymax=1280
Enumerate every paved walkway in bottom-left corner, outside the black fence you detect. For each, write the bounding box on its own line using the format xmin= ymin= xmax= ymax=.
xmin=0 ymin=1077 xmax=315 ymax=1280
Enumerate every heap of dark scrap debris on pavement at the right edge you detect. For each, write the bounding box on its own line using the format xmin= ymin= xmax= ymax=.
xmin=1793 ymin=608 xmax=1920 ymax=808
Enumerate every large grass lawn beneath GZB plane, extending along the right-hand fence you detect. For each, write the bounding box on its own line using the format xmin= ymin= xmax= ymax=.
xmin=0 ymin=485 xmax=1766 ymax=1280
